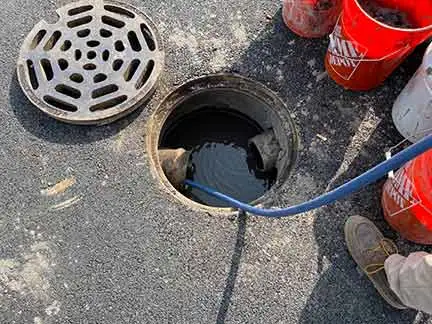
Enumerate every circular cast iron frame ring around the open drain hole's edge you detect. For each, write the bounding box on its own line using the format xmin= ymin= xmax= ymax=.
xmin=146 ymin=73 xmax=299 ymax=215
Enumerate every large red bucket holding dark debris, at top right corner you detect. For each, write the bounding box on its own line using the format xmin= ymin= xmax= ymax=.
xmin=325 ymin=0 xmax=432 ymax=90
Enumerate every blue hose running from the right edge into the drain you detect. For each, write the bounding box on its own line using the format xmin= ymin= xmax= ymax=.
xmin=185 ymin=135 xmax=432 ymax=218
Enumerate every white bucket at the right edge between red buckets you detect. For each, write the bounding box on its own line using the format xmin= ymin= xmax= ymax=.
xmin=392 ymin=44 xmax=432 ymax=143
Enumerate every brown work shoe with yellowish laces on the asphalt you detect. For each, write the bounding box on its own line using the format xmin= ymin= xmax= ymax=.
xmin=345 ymin=216 xmax=407 ymax=309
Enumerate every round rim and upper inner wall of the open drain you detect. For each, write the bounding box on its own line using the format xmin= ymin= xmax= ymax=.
xmin=146 ymin=73 xmax=299 ymax=214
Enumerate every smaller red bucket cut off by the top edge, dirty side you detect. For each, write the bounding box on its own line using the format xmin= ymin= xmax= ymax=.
xmin=282 ymin=0 xmax=342 ymax=38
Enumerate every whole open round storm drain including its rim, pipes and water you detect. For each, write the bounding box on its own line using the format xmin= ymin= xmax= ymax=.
xmin=147 ymin=74 xmax=298 ymax=209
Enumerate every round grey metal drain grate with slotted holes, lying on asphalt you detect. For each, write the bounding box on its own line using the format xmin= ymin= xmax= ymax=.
xmin=18 ymin=0 xmax=164 ymax=124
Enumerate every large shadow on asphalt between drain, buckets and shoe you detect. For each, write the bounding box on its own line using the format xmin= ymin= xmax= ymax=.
xmin=231 ymin=7 xmax=427 ymax=323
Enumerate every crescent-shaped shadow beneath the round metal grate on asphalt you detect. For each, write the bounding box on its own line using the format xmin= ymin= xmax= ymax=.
xmin=9 ymin=73 xmax=145 ymax=144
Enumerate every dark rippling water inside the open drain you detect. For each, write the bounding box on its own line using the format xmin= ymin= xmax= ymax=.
xmin=161 ymin=108 xmax=277 ymax=207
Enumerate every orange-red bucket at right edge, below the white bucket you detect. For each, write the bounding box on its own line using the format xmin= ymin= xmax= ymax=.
xmin=382 ymin=150 xmax=432 ymax=245
